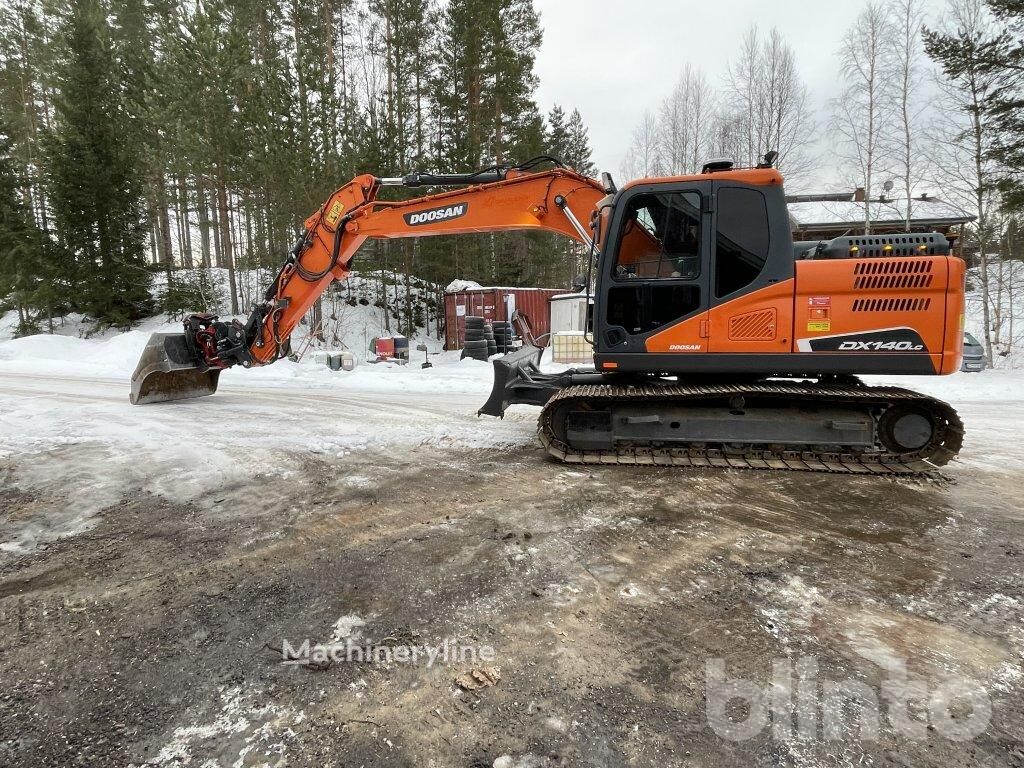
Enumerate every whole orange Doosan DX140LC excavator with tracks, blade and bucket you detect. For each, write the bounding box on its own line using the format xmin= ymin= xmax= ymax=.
xmin=131 ymin=153 xmax=965 ymax=474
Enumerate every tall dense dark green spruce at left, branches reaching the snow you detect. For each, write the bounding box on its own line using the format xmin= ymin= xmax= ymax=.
xmin=47 ymin=0 xmax=151 ymax=327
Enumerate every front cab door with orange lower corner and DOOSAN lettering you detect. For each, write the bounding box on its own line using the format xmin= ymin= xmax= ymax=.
xmin=595 ymin=181 xmax=711 ymax=355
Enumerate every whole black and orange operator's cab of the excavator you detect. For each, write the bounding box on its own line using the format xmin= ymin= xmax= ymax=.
xmin=594 ymin=174 xmax=794 ymax=374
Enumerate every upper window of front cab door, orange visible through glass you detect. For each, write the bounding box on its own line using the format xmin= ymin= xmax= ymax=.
xmin=614 ymin=191 xmax=700 ymax=281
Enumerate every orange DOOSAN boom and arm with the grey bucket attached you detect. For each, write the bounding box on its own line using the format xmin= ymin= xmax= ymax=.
xmin=131 ymin=159 xmax=605 ymax=404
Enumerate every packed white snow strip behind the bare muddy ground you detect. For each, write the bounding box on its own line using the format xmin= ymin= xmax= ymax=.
xmin=0 ymin=324 xmax=1024 ymax=553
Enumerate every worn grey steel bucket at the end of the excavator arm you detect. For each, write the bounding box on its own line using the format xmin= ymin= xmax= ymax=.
xmin=129 ymin=334 xmax=220 ymax=406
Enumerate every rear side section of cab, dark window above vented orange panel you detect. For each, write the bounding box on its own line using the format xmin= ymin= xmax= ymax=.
xmin=708 ymin=181 xmax=794 ymax=354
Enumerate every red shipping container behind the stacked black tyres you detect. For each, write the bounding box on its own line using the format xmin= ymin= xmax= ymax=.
xmin=444 ymin=288 xmax=565 ymax=349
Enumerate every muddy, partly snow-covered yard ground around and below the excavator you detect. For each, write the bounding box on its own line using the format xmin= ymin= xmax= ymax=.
xmin=0 ymin=372 xmax=1024 ymax=768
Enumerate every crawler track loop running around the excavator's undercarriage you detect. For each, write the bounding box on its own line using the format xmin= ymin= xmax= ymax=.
xmin=540 ymin=382 xmax=964 ymax=475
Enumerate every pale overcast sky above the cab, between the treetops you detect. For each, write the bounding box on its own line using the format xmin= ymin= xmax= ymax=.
xmin=535 ymin=0 xmax=942 ymax=186
